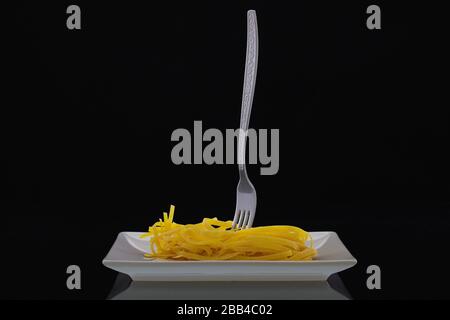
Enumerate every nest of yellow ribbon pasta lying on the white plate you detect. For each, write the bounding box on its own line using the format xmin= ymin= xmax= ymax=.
xmin=142 ymin=205 xmax=317 ymax=261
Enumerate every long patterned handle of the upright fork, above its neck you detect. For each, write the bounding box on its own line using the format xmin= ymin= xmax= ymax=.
xmin=237 ymin=10 xmax=258 ymax=170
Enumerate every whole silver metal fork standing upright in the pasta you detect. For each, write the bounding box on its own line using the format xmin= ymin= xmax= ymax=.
xmin=232 ymin=10 xmax=258 ymax=229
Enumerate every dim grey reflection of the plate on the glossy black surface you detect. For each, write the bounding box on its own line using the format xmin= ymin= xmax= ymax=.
xmin=108 ymin=274 xmax=351 ymax=300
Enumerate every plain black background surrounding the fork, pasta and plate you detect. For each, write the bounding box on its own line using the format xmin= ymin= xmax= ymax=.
xmin=4 ymin=1 xmax=450 ymax=299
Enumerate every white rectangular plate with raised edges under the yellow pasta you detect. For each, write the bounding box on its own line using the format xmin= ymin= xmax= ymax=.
xmin=103 ymin=232 xmax=356 ymax=281
